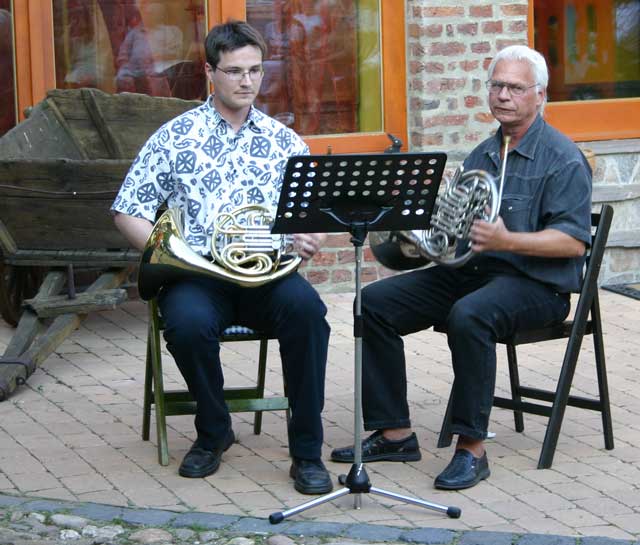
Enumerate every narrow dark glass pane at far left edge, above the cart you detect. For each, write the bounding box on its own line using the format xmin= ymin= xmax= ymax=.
xmin=0 ymin=0 xmax=16 ymax=135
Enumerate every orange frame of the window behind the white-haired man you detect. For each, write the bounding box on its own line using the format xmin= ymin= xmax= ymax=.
xmin=528 ymin=0 xmax=640 ymax=142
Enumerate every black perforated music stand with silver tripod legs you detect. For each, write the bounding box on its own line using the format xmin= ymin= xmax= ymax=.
xmin=269 ymin=153 xmax=461 ymax=524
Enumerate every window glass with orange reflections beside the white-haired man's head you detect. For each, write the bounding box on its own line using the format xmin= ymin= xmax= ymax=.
xmin=534 ymin=0 xmax=640 ymax=101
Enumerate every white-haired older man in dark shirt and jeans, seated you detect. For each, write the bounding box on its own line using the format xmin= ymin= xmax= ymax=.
xmin=331 ymin=46 xmax=591 ymax=490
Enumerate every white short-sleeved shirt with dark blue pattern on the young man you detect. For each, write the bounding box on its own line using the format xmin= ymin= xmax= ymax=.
xmin=111 ymin=96 xmax=309 ymax=255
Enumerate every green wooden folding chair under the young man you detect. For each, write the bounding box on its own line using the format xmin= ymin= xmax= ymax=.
xmin=142 ymin=299 xmax=289 ymax=466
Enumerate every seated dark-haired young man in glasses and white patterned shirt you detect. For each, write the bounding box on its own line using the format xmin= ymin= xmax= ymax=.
xmin=113 ymin=22 xmax=332 ymax=494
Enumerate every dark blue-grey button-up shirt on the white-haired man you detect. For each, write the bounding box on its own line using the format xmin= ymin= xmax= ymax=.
xmin=464 ymin=116 xmax=591 ymax=293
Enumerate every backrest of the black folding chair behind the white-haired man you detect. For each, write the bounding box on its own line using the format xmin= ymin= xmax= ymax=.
xmin=574 ymin=204 xmax=613 ymax=333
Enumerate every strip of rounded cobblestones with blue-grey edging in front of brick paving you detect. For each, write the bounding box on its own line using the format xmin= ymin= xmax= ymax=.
xmin=0 ymin=495 xmax=638 ymax=545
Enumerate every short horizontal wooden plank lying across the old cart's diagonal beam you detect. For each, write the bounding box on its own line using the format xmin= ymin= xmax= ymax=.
xmin=24 ymin=288 xmax=127 ymax=318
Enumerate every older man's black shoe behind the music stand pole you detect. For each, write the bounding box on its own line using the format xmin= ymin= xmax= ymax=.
xmin=331 ymin=430 xmax=422 ymax=463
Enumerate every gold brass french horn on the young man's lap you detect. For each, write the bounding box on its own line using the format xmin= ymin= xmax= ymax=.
xmin=138 ymin=205 xmax=302 ymax=301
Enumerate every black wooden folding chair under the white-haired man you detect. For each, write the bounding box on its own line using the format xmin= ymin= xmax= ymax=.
xmin=435 ymin=204 xmax=613 ymax=469
